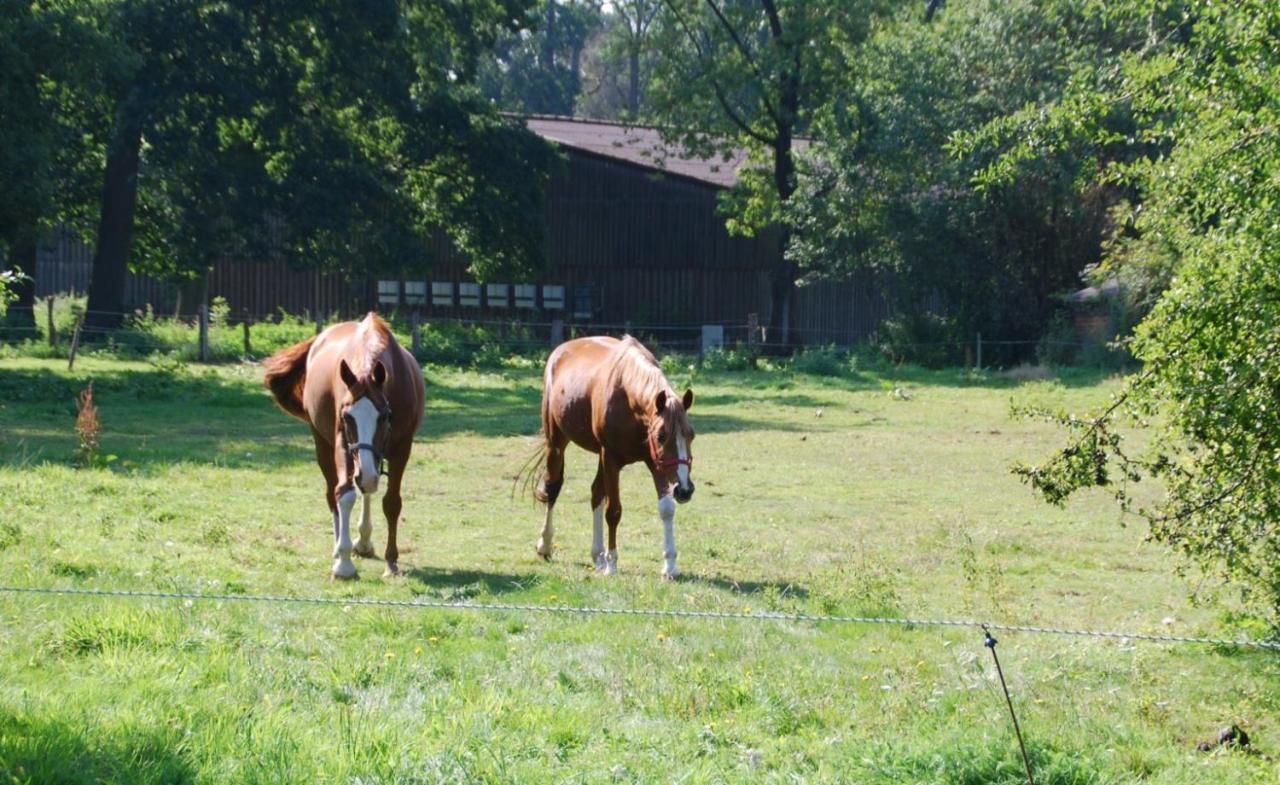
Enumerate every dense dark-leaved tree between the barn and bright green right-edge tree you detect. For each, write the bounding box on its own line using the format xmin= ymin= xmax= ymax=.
xmin=788 ymin=0 xmax=1162 ymax=361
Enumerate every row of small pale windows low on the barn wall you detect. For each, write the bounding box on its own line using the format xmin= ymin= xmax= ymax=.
xmin=378 ymin=279 xmax=594 ymax=318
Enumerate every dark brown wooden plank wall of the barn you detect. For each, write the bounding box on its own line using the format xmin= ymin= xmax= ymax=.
xmin=36 ymin=151 xmax=888 ymax=343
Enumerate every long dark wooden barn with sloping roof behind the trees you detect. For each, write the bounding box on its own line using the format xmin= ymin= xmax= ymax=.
xmin=36 ymin=117 xmax=887 ymax=343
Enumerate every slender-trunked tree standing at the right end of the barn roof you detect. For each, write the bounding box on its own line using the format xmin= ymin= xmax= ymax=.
xmin=650 ymin=0 xmax=887 ymax=343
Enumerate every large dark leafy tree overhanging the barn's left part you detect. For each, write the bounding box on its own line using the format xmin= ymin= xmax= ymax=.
xmin=78 ymin=0 xmax=552 ymax=327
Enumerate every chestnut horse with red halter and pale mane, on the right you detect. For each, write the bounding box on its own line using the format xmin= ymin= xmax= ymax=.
xmin=534 ymin=336 xmax=694 ymax=579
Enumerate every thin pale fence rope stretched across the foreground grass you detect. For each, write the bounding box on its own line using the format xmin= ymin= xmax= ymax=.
xmin=0 ymin=585 xmax=1280 ymax=652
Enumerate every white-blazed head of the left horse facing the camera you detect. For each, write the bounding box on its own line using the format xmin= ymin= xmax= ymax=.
xmin=338 ymin=360 xmax=392 ymax=493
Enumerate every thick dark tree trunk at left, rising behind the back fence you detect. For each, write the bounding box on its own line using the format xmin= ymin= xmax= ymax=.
xmin=84 ymin=110 xmax=142 ymax=329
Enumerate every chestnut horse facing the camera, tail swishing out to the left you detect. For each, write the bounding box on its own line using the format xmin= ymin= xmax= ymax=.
xmin=264 ymin=312 xmax=426 ymax=579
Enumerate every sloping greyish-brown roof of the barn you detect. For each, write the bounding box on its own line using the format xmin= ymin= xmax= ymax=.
xmin=525 ymin=115 xmax=778 ymax=188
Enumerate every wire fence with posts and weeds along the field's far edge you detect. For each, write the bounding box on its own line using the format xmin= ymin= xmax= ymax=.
xmin=0 ymin=298 xmax=1097 ymax=368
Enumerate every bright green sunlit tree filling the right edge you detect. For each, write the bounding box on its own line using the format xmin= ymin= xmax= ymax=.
xmin=983 ymin=0 xmax=1280 ymax=629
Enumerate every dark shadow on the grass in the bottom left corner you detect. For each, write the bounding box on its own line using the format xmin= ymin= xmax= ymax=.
xmin=0 ymin=711 xmax=196 ymax=785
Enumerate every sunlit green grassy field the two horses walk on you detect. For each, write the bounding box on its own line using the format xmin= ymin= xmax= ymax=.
xmin=0 ymin=357 xmax=1280 ymax=785
